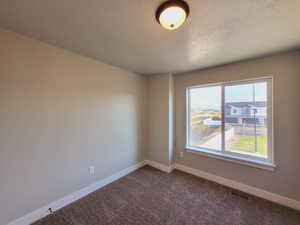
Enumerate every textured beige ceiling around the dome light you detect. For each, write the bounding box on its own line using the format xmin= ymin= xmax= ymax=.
xmin=0 ymin=0 xmax=300 ymax=74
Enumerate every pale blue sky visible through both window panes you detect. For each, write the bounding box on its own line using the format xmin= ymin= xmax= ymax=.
xmin=190 ymin=82 xmax=267 ymax=109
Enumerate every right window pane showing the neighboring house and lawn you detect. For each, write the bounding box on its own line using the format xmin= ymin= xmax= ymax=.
xmin=224 ymin=82 xmax=268 ymax=157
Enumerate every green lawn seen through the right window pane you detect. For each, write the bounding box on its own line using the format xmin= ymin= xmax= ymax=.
xmin=230 ymin=134 xmax=267 ymax=155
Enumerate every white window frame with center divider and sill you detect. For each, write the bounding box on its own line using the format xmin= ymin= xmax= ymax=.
xmin=185 ymin=76 xmax=276 ymax=170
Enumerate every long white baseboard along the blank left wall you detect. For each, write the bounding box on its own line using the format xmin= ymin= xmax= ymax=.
xmin=7 ymin=161 xmax=146 ymax=225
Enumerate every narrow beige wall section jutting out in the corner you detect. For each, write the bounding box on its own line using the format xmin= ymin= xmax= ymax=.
xmin=145 ymin=74 xmax=173 ymax=166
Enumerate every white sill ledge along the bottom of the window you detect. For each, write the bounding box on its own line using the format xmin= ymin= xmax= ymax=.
xmin=185 ymin=147 xmax=276 ymax=171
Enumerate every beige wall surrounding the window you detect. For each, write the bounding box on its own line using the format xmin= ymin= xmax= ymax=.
xmin=175 ymin=51 xmax=300 ymax=200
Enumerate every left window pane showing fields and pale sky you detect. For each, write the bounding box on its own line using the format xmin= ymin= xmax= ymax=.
xmin=189 ymin=86 xmax=222 ymax=151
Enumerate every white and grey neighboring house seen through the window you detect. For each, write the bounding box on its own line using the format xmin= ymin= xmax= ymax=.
xmin=225 ymin=101 xmax=267 ymax=125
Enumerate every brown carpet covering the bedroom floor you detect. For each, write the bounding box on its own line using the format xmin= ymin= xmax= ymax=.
xmin=34 ymin=166 xmax=300 ymax=225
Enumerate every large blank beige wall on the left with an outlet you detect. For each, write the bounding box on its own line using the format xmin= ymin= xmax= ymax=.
xmin=0 ymin=30 xmax=146 ymax=224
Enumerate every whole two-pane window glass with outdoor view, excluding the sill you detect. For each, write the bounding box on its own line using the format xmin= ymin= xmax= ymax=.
xmin=187 ymin=79 xmax=272 ymax=161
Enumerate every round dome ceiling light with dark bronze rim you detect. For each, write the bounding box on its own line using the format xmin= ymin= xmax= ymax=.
xmin=156 ymin=0 xmax=190 ymax=30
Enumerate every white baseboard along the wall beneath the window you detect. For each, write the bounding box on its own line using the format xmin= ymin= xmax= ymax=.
xmin=174 ymin=164 xmax=300 ymax=210
